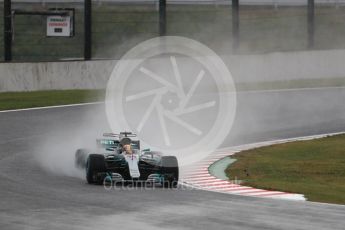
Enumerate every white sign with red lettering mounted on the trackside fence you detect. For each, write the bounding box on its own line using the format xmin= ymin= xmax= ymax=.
xmin=47 ymin=16 xmax=73 ymax=37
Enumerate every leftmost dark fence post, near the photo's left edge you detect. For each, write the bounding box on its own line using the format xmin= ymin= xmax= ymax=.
xmin=4 ymin=0 xmax=12 ymax=62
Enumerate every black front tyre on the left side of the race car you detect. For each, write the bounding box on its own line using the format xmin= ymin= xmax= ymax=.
xmin=86 ymin=154 xmax=106 ymax=184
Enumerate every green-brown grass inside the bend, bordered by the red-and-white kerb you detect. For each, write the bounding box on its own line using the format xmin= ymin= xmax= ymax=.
xmin=225 ymin=135 xmax=345 ymax=204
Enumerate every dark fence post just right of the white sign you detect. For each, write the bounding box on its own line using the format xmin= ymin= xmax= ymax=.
xmin=84 ymin=0 xmax=92 ymax=60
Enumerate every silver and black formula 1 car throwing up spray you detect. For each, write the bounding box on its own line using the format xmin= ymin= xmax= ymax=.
xmin=75 ymin=132 xmax=179 ymax=187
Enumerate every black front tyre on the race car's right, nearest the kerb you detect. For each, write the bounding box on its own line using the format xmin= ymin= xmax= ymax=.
xmin=161 ymin=156 xmax=179 ymax=188
